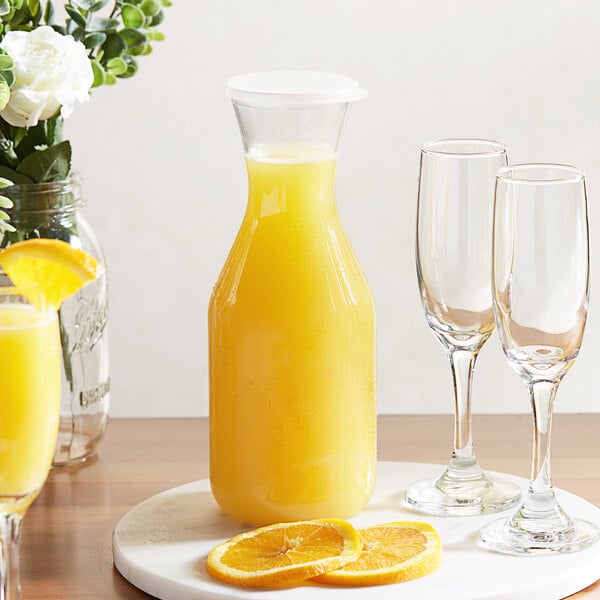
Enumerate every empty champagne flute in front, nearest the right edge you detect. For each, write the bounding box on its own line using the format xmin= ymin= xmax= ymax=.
xmin=481 ymin=164 xmax=600 ymax=554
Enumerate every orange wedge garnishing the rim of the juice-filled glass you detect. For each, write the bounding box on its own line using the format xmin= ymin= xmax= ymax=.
xmin=0 ymin=238 xmax=104 ymax=310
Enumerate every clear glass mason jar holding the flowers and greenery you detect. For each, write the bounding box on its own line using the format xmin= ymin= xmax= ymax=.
xmin=0 ymin=174 xmax=110 ymax=467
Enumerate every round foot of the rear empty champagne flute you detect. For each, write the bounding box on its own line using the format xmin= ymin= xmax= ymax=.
xmin=405 ymin=469 xmax=521 ymax=517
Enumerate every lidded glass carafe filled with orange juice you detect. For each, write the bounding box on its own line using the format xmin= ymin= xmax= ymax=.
xmin=209 ymin=72 xmax=376 ymax=525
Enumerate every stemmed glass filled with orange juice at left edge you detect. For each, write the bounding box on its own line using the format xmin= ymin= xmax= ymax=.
xmin=0 ymin=287 xmax=61 ymax=600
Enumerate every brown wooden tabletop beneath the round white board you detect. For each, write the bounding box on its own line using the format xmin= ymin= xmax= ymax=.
xmin=21 ymin=414 xmax=600 ymax=600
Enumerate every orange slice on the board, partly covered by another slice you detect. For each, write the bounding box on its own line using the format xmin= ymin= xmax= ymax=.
xmin=315 ymin=521 xmax=442 ymax=586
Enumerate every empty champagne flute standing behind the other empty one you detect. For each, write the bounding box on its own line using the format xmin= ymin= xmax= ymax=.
xmin=406 ymin=139 xmax=520 ymax=515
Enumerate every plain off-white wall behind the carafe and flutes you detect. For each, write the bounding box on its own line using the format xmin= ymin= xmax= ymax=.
xmin=66 ymin=0 xmax=600 ymax=416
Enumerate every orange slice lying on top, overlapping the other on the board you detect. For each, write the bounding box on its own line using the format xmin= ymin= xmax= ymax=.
xmin=206 ymin=519 xmax=362 ymax=587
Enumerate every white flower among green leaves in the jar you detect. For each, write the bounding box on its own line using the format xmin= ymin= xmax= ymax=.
xmin=0 ymin=26 xmax=94 ymax=127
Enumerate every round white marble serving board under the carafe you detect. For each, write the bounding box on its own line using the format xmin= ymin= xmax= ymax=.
xmin=113 ymin=462 xmax=600 ymax=600
